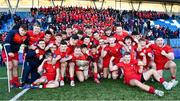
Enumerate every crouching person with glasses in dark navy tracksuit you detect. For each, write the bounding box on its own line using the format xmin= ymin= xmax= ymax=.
xmin=22 ymin=40 xmax=45 ymax=88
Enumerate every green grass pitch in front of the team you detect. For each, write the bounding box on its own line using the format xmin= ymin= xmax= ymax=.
xmin=0 ymin=60 xmax=180 ymax=100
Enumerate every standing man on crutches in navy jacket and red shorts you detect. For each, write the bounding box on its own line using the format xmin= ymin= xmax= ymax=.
xmin=2 ymin=24 xmax=28 ymax=87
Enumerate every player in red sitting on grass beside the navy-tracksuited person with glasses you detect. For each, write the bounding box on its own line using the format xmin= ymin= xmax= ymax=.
xmin=32 ymin=51 xmax=59 ymax=88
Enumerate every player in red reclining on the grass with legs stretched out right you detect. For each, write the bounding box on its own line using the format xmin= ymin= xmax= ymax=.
xmin=110 ymin=52 xmax=176 ymax=96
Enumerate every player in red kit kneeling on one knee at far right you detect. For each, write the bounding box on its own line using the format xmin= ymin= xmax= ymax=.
xmin=149 ymin=37 xmax=178 ymax=87
